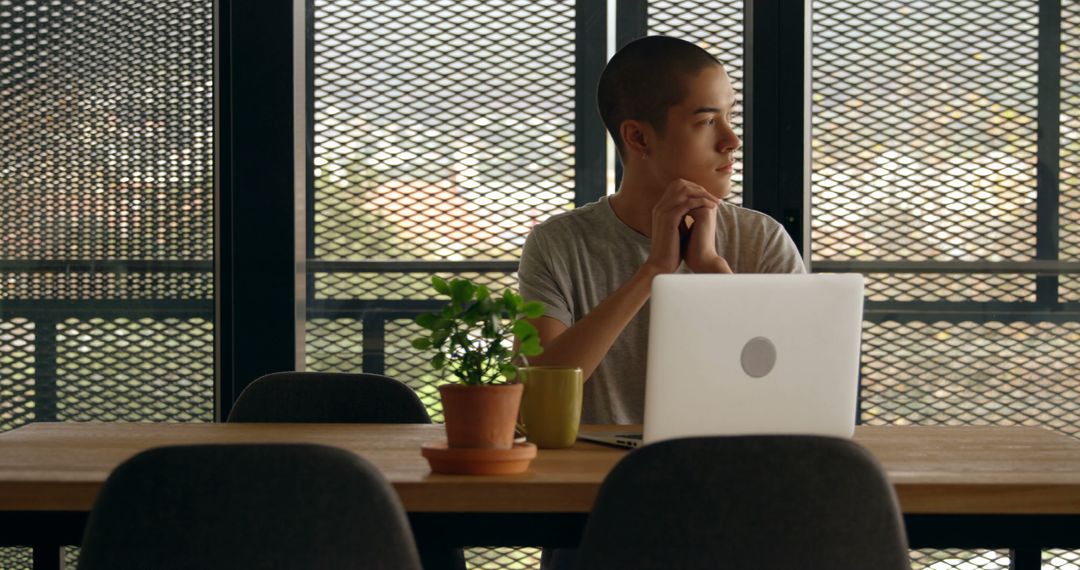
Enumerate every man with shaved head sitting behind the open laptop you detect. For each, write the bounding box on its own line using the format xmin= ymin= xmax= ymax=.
xmin=518 ymin=36 xmax=806 ymax=423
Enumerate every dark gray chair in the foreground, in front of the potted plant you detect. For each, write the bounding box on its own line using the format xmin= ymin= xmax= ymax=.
xmin=79 ymin=444 xmax=420 ymax=570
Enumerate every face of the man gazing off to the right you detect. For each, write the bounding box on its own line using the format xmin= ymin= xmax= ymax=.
xmin=654 ymin=66 xmax=742 ymax=198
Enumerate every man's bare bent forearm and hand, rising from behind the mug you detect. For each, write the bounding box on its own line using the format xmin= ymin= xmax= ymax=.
xmin=520 ymin=180 xmax=719 ymax=379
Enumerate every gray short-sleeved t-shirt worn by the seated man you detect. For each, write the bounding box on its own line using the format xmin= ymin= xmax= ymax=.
xmin=517 ymin=196 xmax=806 ymax=423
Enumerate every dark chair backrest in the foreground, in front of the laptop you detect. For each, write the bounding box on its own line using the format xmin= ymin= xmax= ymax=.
xmin=577 ymin=436 xmax=910 ymax=570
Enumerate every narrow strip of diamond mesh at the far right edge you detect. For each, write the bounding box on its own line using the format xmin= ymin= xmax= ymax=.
xmin=1058 ymin=0 xmax=1080 ymax=302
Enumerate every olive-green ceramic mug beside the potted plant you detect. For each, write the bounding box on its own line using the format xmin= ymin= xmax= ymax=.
xmin=517 ymin=366 xmax=584 ymax=449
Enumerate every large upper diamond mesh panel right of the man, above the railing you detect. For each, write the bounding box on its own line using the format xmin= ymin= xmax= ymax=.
xmin=811 ymin=0 xmax=1038 ymax=272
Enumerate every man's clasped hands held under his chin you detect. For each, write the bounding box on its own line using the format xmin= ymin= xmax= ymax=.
xmin=645 ymin=178 xmax=731 ymax=273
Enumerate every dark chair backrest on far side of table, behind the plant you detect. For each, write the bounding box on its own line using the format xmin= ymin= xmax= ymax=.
xmin=228 ymin=372 xmax=431 ymax=423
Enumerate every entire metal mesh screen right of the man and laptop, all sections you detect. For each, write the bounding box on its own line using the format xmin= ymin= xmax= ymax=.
xmin=811 ymin=0 xmax=1080 ymax=570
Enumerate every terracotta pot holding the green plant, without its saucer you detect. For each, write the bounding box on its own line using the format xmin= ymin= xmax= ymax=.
xmin=438 ymin=384 xmax=525 ymax=449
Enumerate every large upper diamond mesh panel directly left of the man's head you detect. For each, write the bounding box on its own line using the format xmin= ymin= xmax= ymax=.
xmin=313 ymin=0 xmax=575 ymax=260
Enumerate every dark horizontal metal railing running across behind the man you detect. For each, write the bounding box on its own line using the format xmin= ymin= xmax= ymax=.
xmin=6 ymin=260 xmax=1080 ymax=421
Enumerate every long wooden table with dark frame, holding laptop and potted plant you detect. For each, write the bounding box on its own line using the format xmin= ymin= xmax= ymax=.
xmin=0 ymin=423 xmax=1080 ymax=568
